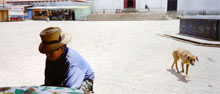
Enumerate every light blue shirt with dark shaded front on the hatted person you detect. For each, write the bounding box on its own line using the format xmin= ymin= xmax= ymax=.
xmin=45 ymin=47 xmax=94 ymax=89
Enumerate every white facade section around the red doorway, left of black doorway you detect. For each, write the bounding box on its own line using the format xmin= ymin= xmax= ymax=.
xmin=94 ymin=0 xmax=174 ymax=13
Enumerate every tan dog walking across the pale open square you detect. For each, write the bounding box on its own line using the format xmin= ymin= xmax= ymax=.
xmin=172 ymin=48 xmax=199 ymax=78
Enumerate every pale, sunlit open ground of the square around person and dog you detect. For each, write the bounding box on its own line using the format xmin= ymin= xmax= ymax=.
xmin=0 ymin=20 xmax=220 ymax=94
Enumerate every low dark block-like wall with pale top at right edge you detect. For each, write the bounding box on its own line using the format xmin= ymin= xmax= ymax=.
xmin=180 ymin=16 xmax=220 ymax=41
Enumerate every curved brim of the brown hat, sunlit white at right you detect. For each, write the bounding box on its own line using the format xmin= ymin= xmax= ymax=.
xmin=39 ymin=33 xmax=71 ymax=54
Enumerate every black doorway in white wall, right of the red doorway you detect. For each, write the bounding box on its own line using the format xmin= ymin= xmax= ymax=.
xmin=167 ymin=0 xmax=177 ymax=11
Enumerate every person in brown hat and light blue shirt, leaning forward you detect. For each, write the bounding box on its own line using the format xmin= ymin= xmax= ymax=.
xmin=39 ymin=27 xmax=94 ymax=92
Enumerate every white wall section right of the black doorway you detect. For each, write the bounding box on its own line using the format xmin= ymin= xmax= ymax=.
xmin=178 ymin=0 xmax=220 ymax=15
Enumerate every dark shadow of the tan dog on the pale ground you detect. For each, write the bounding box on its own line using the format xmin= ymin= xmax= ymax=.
xmin=167 ymin=68 xmax=190 ymax=83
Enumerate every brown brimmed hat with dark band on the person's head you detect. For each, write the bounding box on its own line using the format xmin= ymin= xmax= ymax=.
xmin=39 ymin=27 xmax=71 ymax=54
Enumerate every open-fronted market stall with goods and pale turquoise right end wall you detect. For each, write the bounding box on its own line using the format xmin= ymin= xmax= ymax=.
xmin=28 ymin=6 xmax=91 ymax=20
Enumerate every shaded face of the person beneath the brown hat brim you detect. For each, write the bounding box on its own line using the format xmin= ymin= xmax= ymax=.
xmin=46 ymin=48 xmax=63 ymax=61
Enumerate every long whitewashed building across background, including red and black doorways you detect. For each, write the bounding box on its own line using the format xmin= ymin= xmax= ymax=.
xmin=3 ymin=0 xmax=220 ymax=15
